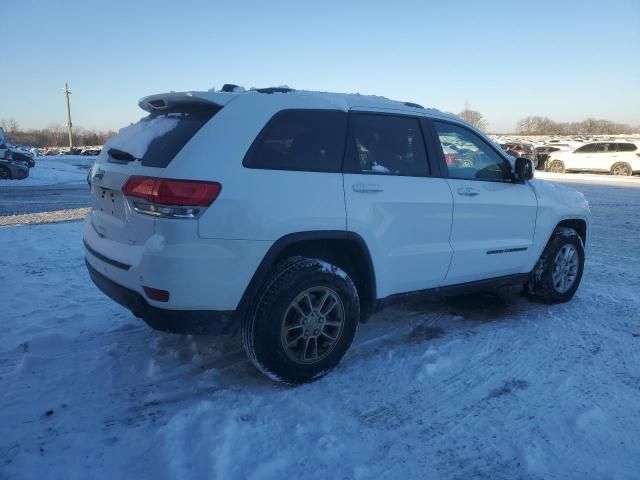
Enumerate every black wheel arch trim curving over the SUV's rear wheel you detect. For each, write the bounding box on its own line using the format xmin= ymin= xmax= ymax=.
xmin=236 ymin=230 xmax=377 ymax=321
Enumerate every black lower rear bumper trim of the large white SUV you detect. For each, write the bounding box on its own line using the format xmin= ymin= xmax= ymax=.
xmin=85 ymin=259 xmax=239 ymax=335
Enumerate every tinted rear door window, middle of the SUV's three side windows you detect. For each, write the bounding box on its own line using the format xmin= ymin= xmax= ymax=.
xmin=345 ymin=113 xmax=429 ymax=177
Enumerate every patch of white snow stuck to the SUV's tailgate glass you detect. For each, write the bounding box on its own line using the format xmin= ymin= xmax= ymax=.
xmin=104 ymin=117 xmax=178 ymax=158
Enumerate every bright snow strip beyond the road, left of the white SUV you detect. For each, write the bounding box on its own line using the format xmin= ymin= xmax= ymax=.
xmin=0 ymin=155 xmax=98 ymax=188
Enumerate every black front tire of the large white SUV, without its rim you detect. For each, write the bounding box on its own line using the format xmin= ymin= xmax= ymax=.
xmin=527 ymin=227 xmax=584 ymax=303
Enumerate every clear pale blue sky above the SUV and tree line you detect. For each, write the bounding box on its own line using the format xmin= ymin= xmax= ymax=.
xmin=0 ymin=0 xmax=640 ymax=132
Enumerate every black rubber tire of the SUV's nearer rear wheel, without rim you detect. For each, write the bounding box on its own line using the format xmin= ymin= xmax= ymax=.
xmin=242 ymin=257 xmax=360 ymax=385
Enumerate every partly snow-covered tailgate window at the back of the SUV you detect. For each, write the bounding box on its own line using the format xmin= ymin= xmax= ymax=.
xmin=106 ymin=104 xmax=222 ymax=168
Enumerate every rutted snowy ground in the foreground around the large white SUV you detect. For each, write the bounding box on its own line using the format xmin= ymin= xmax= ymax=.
xmin=0 ymin=176 xmax=640 ymax=480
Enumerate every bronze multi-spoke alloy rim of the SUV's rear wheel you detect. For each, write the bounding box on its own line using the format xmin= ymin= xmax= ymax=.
xmin=280 ymin=286 xmax=345 ymax=364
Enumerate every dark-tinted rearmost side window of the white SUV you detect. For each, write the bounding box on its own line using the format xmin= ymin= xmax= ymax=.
xmin=243 ymin=110 xmax=347 ymax=172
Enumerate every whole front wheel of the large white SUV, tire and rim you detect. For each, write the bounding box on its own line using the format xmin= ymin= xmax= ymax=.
xmin=527 ymin=227 xmax=584 ymax=303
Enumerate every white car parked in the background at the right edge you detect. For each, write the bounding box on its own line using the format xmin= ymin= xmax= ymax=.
xmin=547 ymin=141 xmax=640 ymax=176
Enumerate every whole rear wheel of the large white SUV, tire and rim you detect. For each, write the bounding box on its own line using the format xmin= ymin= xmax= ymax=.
xmin=242 ymin=257 xmax=360 ymax=384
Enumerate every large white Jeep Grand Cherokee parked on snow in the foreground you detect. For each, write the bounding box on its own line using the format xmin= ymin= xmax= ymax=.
xmin=84 ymin=86 xmax=589 ymax=383
